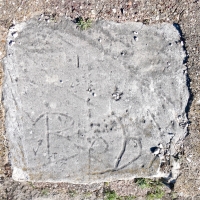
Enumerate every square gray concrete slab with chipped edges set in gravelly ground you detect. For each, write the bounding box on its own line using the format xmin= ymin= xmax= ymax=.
xmin=3 ymin=19 xmax=189 ymax=183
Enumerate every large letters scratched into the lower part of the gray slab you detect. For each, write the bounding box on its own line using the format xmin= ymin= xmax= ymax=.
xmin=30 ymin=113 xmax=142 ymax=174
